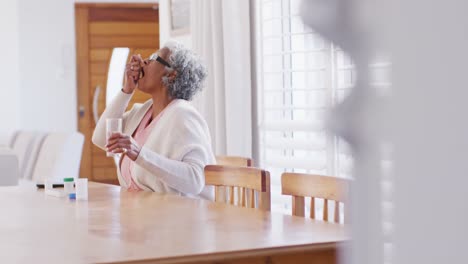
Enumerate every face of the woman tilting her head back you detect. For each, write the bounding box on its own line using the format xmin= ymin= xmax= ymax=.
xmin=138 ymin=48 xmax=170 ymax=94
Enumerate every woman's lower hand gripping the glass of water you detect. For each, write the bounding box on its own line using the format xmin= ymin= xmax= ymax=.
xmin=106 ymin=133 xmax=141 ymax=161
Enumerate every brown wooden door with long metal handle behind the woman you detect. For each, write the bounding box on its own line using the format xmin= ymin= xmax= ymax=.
xmin=75 ymin=3 xmax=159 ymax=183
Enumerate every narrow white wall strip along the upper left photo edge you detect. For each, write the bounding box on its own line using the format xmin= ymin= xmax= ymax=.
xmin=0 ymin=0 xmax=20 ymax=131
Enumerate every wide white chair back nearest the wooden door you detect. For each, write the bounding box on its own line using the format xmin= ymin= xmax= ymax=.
xmin=32 ymin=132 xmax=84 ymax=182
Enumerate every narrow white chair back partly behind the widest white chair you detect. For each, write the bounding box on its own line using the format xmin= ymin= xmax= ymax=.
xmin=13 ymin=131 xmax=46 ymax=180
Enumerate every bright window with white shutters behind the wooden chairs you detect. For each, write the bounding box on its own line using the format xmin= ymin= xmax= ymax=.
xmin=257 ymin=0 xmax=356 ymax=214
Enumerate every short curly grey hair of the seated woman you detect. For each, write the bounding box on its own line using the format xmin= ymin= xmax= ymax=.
xmin=162 ymin=41 xmax=207 ymax=101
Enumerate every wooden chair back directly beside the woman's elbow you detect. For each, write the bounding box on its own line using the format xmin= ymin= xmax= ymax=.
xmin=205 ymin=165 xmax=271 ymax=211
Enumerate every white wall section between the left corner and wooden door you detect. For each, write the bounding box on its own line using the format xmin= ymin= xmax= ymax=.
xmin=19 ymin=0 xmax=77 ymax=131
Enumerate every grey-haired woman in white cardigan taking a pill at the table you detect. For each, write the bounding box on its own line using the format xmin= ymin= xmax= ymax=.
xmin=92 ymin=42 xmax=215 ymax=198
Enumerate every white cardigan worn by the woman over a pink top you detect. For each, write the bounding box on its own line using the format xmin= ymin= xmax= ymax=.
xmin=92 ymin=89 xmax=216 ymax=199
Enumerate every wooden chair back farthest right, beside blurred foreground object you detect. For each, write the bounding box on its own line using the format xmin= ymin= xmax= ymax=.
xmin=281 ymin=173 xmax=349 ymax=223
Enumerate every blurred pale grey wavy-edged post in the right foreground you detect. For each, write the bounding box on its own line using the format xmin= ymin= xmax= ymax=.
xmin=301 ymin=0 xmax=384 ymax=264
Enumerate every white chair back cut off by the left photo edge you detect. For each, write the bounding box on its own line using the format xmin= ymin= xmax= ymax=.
xmin=0 ymin=148 xmax=19 ymax=186
